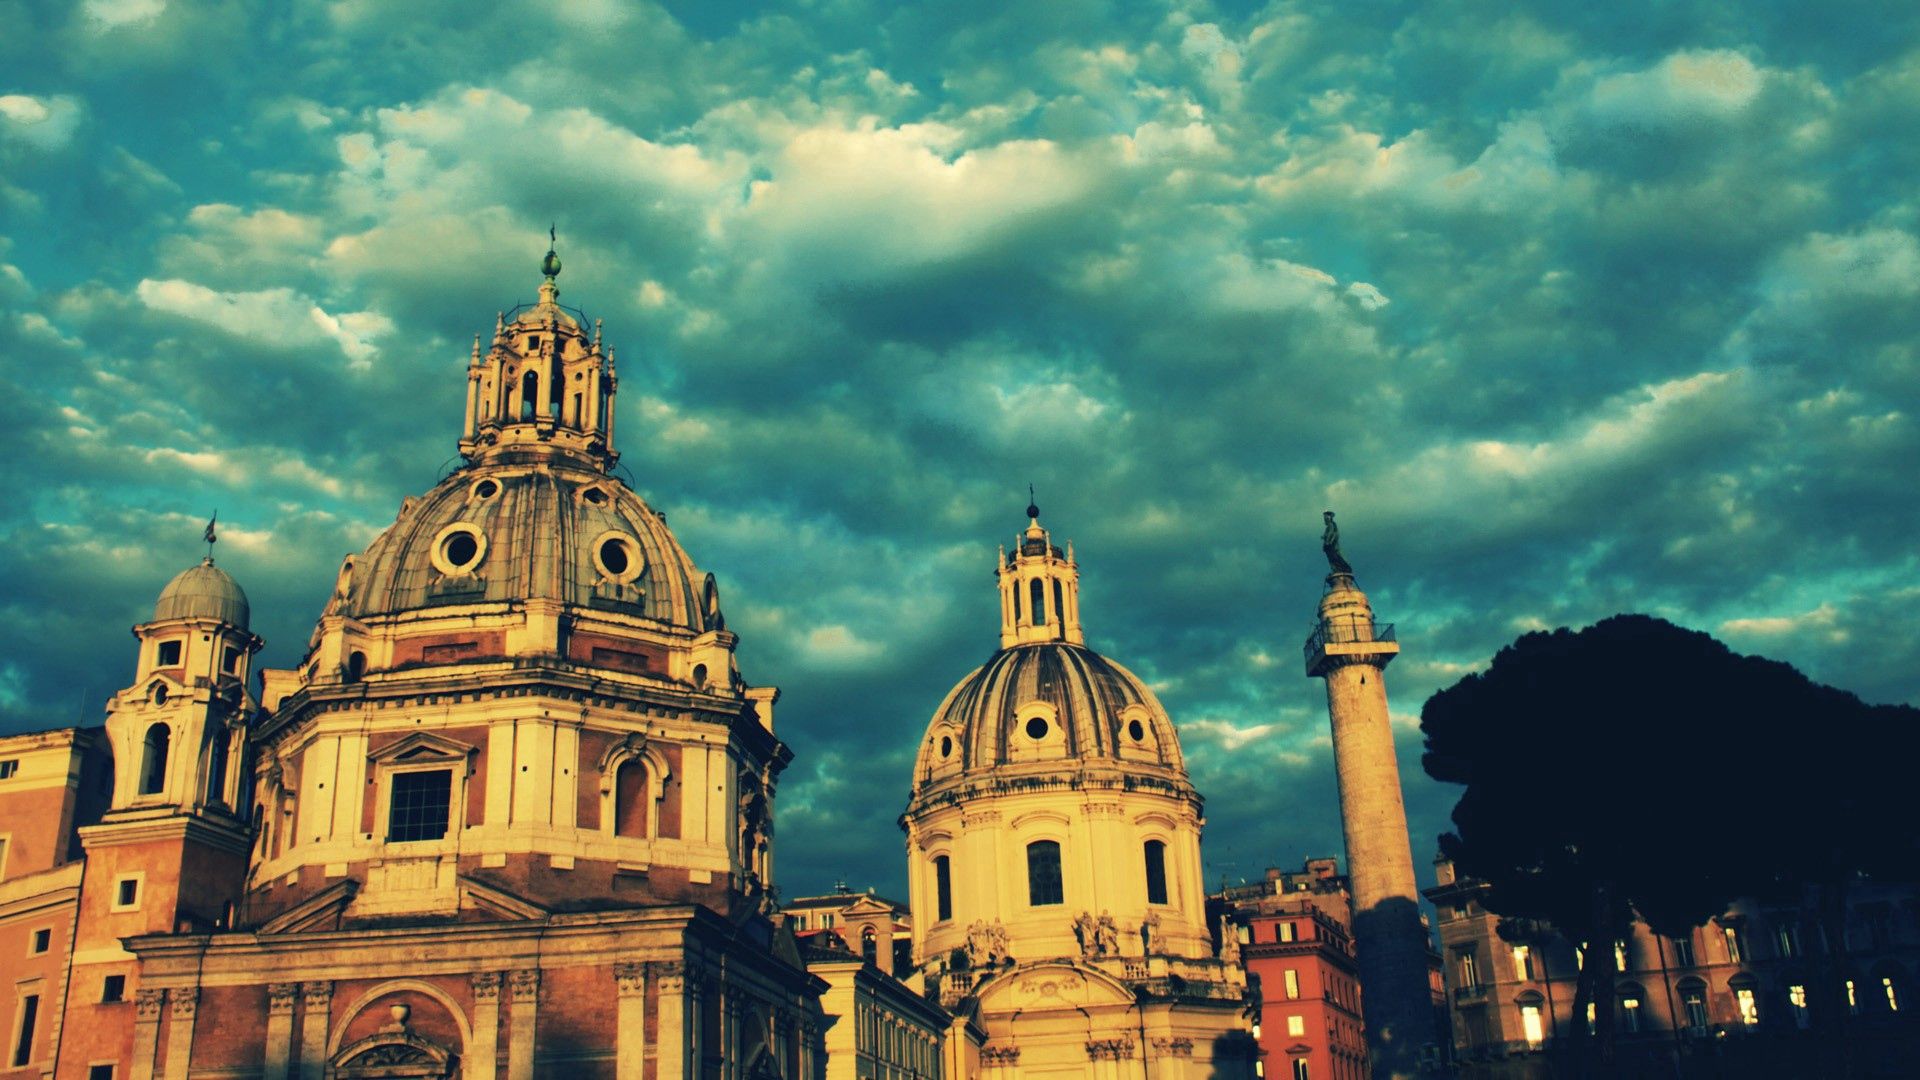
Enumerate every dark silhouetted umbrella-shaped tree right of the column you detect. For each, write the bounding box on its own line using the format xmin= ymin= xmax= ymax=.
xmin=1421 ymin=615 xmax=1920 ymax=1057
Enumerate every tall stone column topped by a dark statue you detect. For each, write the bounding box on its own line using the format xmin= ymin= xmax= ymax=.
xmin=1306 ymin=509 xmax=1434 ymax=1080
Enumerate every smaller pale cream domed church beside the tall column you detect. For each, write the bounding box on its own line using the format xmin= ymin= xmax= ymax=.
xmin=900 ymin=505 xmax=1256 ymax=1080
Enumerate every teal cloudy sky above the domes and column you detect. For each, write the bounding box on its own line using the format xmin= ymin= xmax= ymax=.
xmin=0 ymin=0 xmax=1920 ymax=894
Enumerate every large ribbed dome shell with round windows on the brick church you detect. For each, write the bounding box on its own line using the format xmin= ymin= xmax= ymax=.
xmin=344 ymin=461 xmax=718 ymax=632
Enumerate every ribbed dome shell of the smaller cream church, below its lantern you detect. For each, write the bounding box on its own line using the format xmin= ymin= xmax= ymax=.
xmin=914 ymin=642 xmax=1183 ymax=780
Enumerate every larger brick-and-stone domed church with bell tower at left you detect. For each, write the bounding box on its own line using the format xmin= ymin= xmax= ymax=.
xmin=0 ymin=252 xmax=826 ymax=1080
